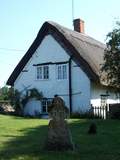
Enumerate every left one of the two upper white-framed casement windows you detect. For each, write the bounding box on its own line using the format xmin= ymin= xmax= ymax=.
xmin=36 ymin=66 xmax=49 ymax=80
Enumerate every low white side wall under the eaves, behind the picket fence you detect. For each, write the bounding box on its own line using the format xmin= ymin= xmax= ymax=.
xmin=91 ymin=84 xmax=119 ymax=106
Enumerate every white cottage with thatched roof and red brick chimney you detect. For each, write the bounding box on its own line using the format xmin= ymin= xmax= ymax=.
xmin=7 ymin=19 xmax=119 ymax=113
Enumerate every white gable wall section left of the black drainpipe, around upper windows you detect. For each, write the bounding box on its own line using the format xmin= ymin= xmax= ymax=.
xmin=14 ymin=35 xmax=69 ymax=106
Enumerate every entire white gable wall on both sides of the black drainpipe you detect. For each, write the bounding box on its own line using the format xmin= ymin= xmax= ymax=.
xmin=14 ymin=35 xmax=90 ymax=111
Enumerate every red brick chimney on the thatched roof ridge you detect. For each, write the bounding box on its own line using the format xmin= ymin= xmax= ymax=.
xmin=73 ymin=18 xmax=84 ymax=33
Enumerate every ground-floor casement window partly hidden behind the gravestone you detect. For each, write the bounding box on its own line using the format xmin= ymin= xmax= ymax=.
xmin=42 ymin=98 xmax=52 ymax=113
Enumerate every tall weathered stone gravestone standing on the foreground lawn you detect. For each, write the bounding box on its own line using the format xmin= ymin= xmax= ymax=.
xmin=45 ymin=97 xmax=74 ymax=150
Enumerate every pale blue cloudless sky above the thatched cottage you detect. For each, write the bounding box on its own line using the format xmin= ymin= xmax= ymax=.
xmin=0 ymin=0 xmax=120 ymax=87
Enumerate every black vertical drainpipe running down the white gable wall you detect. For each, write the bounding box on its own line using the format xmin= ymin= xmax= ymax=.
xmin=69 ymin=57 xmax=72 ymax=114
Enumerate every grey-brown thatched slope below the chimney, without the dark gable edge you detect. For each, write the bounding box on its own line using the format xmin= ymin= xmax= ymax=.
xmin=49 ymin=22 xmax=106 ymax=79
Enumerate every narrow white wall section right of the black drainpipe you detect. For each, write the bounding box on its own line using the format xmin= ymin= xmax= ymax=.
xmin=72 ymin=61 xmax=90 ymax=112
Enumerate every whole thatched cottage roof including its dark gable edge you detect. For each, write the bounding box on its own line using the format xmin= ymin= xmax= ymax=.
xmin=7 ymin=21 xmax=105 ymax=85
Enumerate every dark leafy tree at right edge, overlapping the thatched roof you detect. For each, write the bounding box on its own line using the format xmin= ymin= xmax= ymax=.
xmin=101 ymin=22 xmax=120 ymax=91
